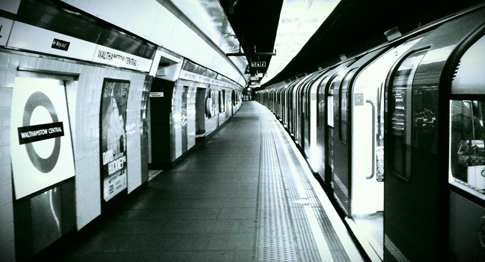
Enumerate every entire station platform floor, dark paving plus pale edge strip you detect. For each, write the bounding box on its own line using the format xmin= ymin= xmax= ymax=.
xmin=44 ymin=102 xmax=364 ymax=262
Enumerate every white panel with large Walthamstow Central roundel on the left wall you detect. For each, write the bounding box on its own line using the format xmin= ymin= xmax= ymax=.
xmin=10 ymin=77 xmax=75 ymax=199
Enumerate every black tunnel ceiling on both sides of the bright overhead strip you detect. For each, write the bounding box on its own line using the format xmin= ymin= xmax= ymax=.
xmin=220 ymin=0 xmax=482 ymax=86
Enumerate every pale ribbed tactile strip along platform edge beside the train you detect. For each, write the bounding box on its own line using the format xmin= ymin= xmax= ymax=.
xmin=255 ymin=108 xmax=350 ymax=262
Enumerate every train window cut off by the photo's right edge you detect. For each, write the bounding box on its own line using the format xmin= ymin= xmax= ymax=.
xmin=450 ymin=100 xmax=485 ymax=194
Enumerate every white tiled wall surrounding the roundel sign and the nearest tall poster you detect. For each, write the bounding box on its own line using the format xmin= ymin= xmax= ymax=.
xmin=0 ymin=49 xmax=146 ymax=261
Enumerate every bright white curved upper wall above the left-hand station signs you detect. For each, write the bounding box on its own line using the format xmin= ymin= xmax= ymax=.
xmin=63 ymin=0 xmax=246 ymax=86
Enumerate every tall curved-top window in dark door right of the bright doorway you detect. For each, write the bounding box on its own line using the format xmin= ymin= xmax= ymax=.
xmin=389 ymin=50 xmax=427 ymax=181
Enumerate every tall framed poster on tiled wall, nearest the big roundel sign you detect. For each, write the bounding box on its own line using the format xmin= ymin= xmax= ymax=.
xmin=101 ymin=79 xmax=130 ymax=201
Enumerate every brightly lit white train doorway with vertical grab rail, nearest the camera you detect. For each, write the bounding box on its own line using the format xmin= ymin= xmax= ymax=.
xmin=350 ymin=37 xmax=421 ymax=260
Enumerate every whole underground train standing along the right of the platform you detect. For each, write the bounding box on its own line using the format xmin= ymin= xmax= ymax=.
xmin=256 ymin=5 xmax=485 ymax=261
